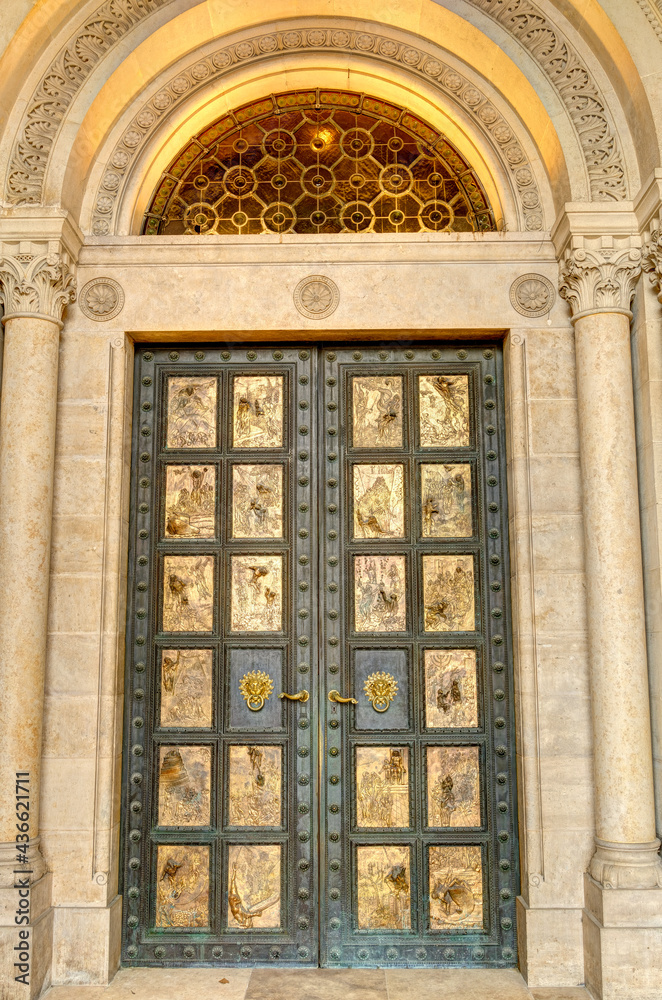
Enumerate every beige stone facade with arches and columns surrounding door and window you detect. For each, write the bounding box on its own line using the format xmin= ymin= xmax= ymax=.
xmin=0 ymin=0 xmax=662 ymax=1000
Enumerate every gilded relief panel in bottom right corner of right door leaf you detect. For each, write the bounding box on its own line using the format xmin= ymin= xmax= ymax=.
xmin=428 ymin=844 xmax=483 ymax=931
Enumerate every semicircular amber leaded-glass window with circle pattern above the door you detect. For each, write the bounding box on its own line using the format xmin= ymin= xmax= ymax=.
xmin=142 ymin=89 xmax=496 ymax=235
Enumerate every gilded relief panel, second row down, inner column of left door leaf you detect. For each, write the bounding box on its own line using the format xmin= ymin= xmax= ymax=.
xmin=232 ymin=465 xmax=283 ymax=538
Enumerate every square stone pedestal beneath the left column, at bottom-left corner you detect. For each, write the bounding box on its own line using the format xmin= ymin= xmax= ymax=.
xmin=0 ymin=873 xmax=53 ymax=1000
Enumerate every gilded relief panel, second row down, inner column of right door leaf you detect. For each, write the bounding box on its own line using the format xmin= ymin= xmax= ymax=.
xmin=354 ymin=465 xmax=405 ymax=538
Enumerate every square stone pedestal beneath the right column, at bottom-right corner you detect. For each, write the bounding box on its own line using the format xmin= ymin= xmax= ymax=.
xmin=583 ymin=875 xmax=662 ymax=1000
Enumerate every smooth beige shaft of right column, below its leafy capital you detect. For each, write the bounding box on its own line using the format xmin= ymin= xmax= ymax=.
xmin=575 ymin=312 xmax=657 ymax=872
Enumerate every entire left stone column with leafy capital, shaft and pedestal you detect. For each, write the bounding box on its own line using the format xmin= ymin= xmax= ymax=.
xmin=0 ymin=241 xmax=75 ymax=997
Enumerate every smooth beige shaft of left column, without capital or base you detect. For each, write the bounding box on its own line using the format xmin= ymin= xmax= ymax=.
xmin=0 ymin=316 xmax=59 ymax=856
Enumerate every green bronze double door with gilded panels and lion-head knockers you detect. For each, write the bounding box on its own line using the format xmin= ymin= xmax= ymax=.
xmin=123 ymin=343 xmax=517 ymax=966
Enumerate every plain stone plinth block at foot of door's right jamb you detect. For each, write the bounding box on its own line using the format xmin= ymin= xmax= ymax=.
xmin=517 ymin=896 xmax=584 ymax=987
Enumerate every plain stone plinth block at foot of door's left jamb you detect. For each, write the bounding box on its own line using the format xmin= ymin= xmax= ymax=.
xmin=52 ymin=896 xmax=122 ymax=986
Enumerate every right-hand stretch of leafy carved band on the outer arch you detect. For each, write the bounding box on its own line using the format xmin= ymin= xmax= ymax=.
xmin=470 ymin=0 xmax=628 ymax=201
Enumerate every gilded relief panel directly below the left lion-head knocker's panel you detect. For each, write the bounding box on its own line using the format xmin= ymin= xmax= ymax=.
xmin=228 ymin=745 xmax=282 ymax=826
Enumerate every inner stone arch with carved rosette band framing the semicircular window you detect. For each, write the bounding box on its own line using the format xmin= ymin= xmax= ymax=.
xmin=75 ymin=18 xmax=554 ymax=236
